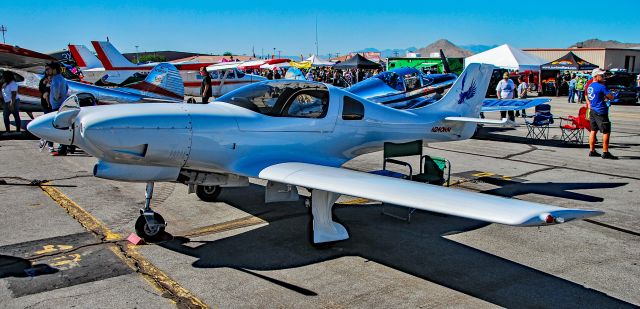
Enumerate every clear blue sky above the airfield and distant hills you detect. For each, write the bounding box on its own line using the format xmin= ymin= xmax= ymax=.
xmin=0 ymin=0 xmax=640 ymax=55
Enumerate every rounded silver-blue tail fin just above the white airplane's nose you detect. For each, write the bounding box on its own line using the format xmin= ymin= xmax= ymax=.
xmin=125 ymin=62 xmax=184 ymax=103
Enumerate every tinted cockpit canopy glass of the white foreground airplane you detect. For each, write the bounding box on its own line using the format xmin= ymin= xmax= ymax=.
xmin=217 ymin=80 xmax=329 ymax=118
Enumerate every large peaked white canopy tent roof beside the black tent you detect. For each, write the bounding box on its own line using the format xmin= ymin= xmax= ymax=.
xmin=464 ymin=44 xmax=549 ymax=71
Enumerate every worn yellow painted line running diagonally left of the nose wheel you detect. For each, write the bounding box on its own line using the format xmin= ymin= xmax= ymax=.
xmin=40 ymin=182 xmax=209 ymax=308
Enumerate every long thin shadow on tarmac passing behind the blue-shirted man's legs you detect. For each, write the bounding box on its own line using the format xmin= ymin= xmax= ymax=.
xmin=473 ymin=127 xmax=640 ymax=149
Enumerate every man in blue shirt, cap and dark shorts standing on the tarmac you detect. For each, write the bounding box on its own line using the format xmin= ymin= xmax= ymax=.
xmin=587 ymin=68 xmax=618 ymax=160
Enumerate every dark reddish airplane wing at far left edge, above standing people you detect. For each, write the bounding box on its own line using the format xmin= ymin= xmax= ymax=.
xmin=0 ymin=44 xmax=56 ymax=73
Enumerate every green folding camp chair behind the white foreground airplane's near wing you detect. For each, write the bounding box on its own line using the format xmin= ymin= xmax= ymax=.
xmin=372 ymin=140 xmax=451 ymax=222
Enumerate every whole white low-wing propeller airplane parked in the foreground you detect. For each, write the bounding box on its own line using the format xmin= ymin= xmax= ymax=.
xmin=28 ymin=64 xmax=602 ymax=243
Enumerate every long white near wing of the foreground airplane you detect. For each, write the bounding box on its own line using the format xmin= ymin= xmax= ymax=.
xmin=259 ymin=163 xmax=603 ymax=226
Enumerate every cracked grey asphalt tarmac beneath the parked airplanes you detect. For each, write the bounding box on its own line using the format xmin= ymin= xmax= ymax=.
xmin=0 ymin=98 xmax=640 ymax=308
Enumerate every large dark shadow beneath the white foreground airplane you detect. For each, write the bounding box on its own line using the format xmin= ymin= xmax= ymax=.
xmin=161 ymin=185 xmax=633 ymax=308
